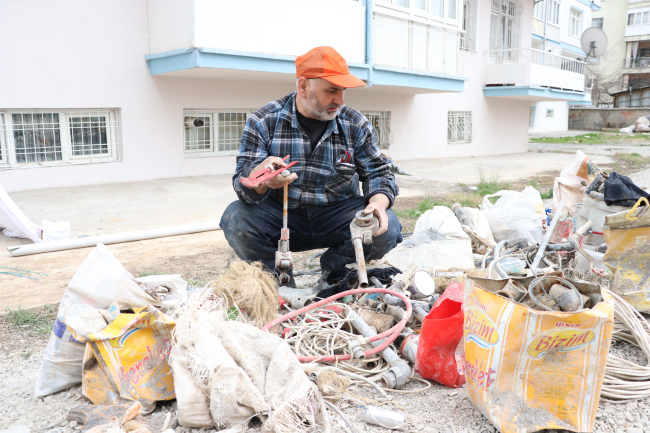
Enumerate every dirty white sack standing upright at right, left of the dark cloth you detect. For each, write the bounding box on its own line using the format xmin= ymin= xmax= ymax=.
xmin=553 ymin=150 xmax=589 ymax=217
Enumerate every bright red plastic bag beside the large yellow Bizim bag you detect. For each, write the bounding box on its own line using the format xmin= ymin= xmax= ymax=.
xmin=415 ymin=283 xmax=465 ymax=388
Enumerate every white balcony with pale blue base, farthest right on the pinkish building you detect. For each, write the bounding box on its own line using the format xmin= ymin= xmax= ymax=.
xmin=484 ymin=48 xmax=585 ymax=101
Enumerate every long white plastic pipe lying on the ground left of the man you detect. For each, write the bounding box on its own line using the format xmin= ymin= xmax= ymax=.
xmin=7 ymin=222 xmax=220 ymax=257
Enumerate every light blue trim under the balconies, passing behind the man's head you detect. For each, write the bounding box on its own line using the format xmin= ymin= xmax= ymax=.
xmin=145 ymin=48 xmax=460 ymax=92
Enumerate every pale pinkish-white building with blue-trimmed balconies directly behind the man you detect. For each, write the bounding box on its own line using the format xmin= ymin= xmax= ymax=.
xmin=0 ymin=0 xmax=588 ymax=191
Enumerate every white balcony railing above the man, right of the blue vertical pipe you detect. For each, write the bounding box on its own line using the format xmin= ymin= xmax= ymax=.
xmin=374 ymin=14 xmax=463 ymax=76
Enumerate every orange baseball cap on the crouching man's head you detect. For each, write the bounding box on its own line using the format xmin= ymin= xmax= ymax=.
xmin=296 ymin=47 xmax=366 ymax=88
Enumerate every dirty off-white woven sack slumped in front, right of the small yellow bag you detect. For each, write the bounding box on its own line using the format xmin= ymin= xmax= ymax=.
xmin=171 ymin=291 xmax=321 ymax=433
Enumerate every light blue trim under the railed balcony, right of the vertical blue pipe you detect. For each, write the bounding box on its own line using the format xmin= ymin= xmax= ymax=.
xmin=373 ymin=66 xmax=467 ymax=92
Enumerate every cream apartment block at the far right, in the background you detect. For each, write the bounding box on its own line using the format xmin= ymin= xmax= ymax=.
xmin=593 ymin=0 xmax=650 ymax=107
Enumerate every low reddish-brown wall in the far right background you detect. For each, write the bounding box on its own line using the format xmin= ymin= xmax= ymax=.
xmin=569 ymin=108 xmax=650 ymax=131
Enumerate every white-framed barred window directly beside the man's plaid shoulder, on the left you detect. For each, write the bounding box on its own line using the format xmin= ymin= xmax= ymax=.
xmin=183 ymin=110 xmax=251 ymax=158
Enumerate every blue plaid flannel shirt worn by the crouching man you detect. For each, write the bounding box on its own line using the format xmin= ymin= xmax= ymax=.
xmin=232 ymin=92 xmax=399 ymax=209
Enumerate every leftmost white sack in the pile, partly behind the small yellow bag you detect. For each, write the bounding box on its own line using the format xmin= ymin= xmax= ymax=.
xmin=34 ymin=244 xmax=178 ymax=397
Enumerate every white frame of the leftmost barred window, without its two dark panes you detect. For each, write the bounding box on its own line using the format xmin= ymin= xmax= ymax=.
xmin=0 ymin=108 xmax=120 ymax=170
